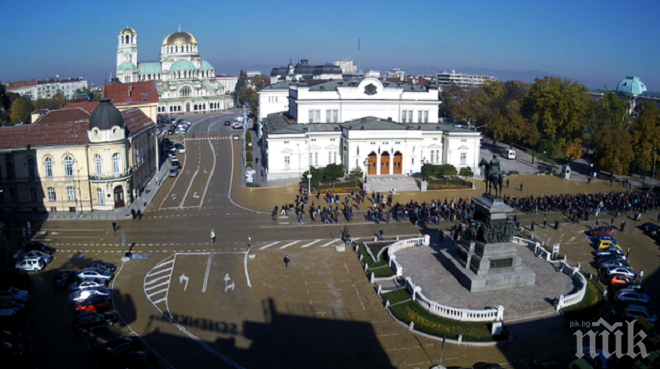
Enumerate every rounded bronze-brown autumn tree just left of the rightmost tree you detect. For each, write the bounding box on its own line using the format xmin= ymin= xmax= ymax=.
xmin=595 ymin=126 xmax=635 ymax=174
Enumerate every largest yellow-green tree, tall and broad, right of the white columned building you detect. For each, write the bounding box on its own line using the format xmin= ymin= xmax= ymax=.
xmin=520 ymin=77 xmax=587 ymax=152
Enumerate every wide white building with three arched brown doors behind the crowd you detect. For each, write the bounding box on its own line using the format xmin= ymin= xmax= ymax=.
xmin=259 ymin=78 xmax=481 ymax=179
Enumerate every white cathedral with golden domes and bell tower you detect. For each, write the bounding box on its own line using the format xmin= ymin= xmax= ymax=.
xmin=117 ymin=26 xmax=234 ymax=113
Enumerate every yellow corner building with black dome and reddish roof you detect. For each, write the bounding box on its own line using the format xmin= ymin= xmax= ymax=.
xmin=0 ymin=99 xmax=158 ymax=213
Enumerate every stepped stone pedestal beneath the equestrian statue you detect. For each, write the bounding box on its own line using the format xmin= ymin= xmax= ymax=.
xmin=440 ymin=195 xmax=536 ymax=292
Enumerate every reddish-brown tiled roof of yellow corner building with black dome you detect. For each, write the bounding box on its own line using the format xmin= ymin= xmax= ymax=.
xmin=0 ymin=108 xmax=154 ymax=149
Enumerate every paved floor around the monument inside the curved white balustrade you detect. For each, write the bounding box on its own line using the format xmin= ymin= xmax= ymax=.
xmin=396 ymin=238 xmax=574 ymax=322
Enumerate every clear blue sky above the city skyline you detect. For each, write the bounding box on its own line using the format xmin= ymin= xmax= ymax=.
xmin=0 ymin=0 xmax=660 ymax=91
